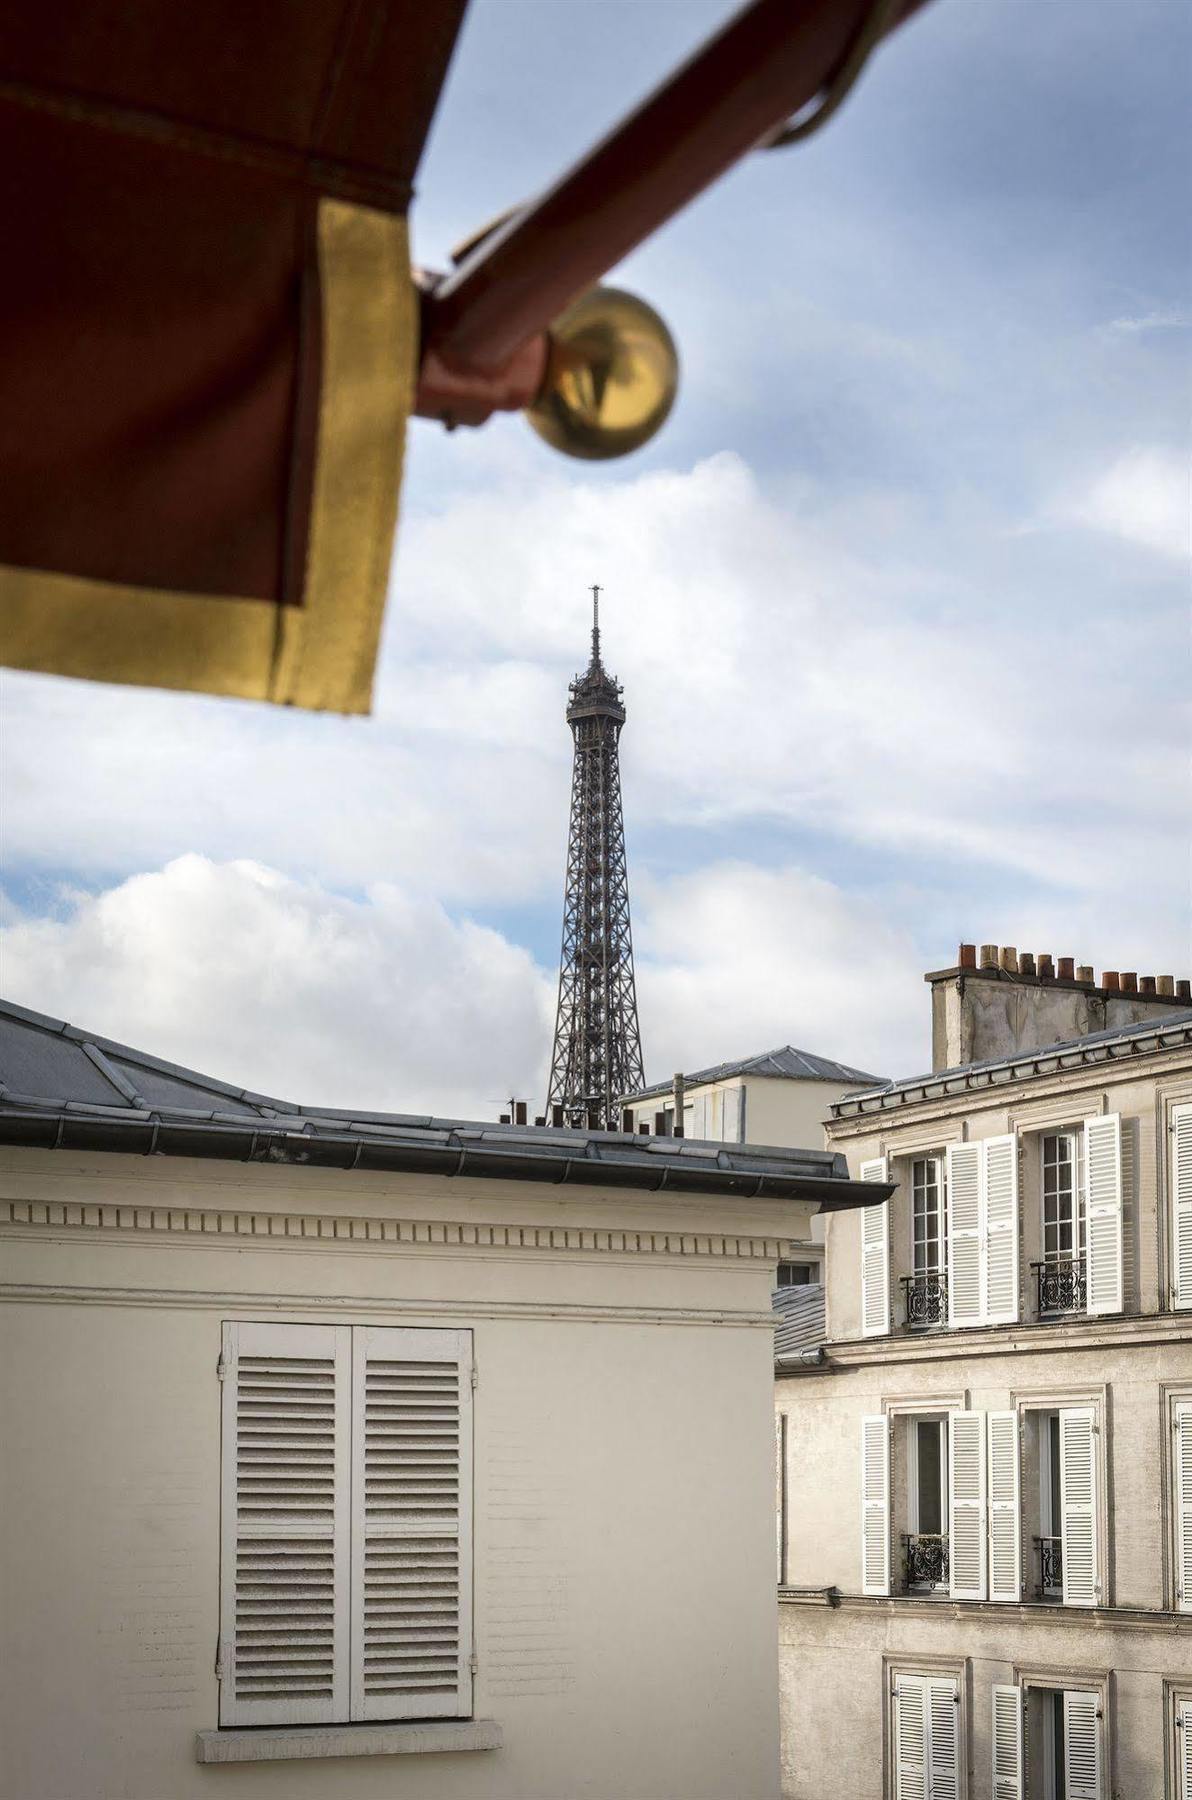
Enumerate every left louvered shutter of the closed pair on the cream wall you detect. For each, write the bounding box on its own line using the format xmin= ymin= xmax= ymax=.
xmin=220 ymin=1323 xmax=351 ymax=1724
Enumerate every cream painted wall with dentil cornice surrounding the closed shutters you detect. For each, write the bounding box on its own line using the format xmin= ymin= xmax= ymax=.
xmin=0 ymin=1152 xmax=807 ymax=1800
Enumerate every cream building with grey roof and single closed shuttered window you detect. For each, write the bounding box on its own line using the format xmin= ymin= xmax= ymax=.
xmin=0 ymin=1006 xmax=878 ymax=1800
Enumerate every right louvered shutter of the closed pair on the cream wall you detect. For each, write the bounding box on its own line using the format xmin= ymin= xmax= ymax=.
xmin=351 ymin=1325 xmax=472 ymax=1719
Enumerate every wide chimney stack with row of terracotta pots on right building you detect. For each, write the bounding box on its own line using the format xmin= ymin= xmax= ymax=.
xmin=936 ymin=943 xmax=1192 ymax=1065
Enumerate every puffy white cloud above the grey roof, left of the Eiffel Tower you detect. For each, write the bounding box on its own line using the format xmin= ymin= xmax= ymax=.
xmin=2 ymin=855 xmax=553 ymax=1118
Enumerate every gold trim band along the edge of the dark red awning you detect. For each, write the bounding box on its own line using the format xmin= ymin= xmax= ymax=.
xmin=0 ymin=200 xmax=418 ymax=713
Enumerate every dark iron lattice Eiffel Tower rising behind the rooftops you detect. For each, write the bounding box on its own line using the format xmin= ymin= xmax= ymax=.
xmin=547 ymin=587 xmax=645 ymax=1130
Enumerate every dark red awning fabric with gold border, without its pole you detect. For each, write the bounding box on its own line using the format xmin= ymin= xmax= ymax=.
xmin=0 ymin=0 xmax=465 ymax=713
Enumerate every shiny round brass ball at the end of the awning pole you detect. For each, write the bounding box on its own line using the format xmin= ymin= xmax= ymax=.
xmin=526 ymin=288 xmax=679 ymax=461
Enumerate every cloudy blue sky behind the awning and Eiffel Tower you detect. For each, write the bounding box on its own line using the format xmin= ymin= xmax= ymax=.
xmin=4 ymin=0 xmax=1192 ymax=1114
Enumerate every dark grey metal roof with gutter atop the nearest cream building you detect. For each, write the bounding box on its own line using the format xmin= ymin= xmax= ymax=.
xmin=0 ymin=1001 xmax=893 ymax=1211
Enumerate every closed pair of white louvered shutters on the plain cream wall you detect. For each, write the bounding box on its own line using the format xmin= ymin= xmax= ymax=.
xmin=220 ymin=1323 xmax=472 ymax=1726
